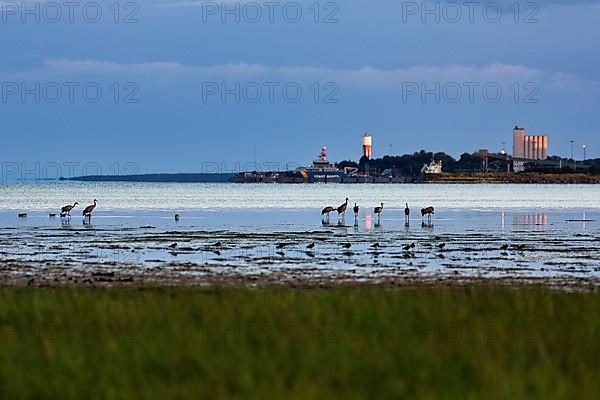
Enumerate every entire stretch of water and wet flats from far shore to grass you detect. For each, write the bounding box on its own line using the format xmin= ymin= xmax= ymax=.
xmin=0 ymin=183 xmax=600 ymax=286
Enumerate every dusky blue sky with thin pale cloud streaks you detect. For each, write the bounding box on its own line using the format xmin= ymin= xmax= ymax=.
xmin=0 ymin=0 xmax=600 ymax=180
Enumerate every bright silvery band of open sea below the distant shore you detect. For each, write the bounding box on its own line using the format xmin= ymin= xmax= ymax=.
xmin=0 ymin=182 xmax=600 ymax=212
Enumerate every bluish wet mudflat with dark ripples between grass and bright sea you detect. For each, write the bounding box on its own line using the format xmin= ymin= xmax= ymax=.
xmin=0 ymin=209 xmax=600 ymax=288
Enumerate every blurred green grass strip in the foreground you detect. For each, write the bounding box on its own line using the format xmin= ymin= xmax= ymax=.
xmin=0 ymin=287 xmax=600 ymax=399
